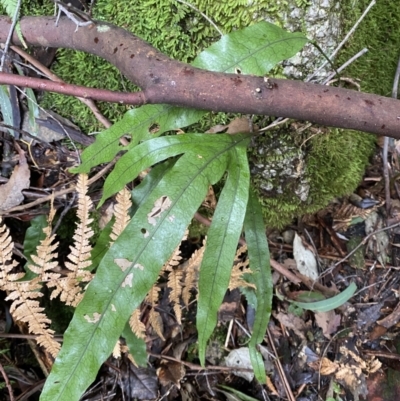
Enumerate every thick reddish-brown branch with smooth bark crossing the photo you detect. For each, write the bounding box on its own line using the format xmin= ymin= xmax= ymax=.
xmin=0 ymin=16 xmax=400 ymax=138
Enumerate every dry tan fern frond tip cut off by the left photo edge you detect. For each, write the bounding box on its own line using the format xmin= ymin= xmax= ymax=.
xmin=0 ymin=216 xmax=25 ymax=291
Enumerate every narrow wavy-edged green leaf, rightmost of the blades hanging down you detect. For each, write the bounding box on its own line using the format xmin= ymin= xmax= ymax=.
xmin=244 ymin=190 xmax=273 ymax=383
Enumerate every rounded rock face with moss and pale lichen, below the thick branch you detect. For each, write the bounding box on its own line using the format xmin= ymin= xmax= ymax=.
xmin=250 ymin=127 xmax=375 ymax=228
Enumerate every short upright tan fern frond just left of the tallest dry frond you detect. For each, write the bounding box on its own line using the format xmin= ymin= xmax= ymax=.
xmin=28 ymin=200 xmax=60 ymax=282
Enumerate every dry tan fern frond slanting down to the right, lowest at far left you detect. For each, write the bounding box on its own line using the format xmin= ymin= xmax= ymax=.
xmin=6 ymin=277 xmax=60 ymax=358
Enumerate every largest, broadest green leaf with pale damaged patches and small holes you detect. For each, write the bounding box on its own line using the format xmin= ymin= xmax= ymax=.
xmin=41 ymin=135 xmax=243 ymax=401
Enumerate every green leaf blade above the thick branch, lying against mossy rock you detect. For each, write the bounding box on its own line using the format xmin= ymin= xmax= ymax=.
xmin=193 ymin=21 xmax=308 ymax=75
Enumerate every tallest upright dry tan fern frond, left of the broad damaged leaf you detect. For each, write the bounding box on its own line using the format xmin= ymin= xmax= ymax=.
xmin=47 ymin=174 xmax=93 ymax=307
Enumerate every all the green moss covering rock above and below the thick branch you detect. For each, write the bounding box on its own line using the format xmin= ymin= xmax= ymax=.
xmin=6 ymin=0 xmax=400 ymax=227
